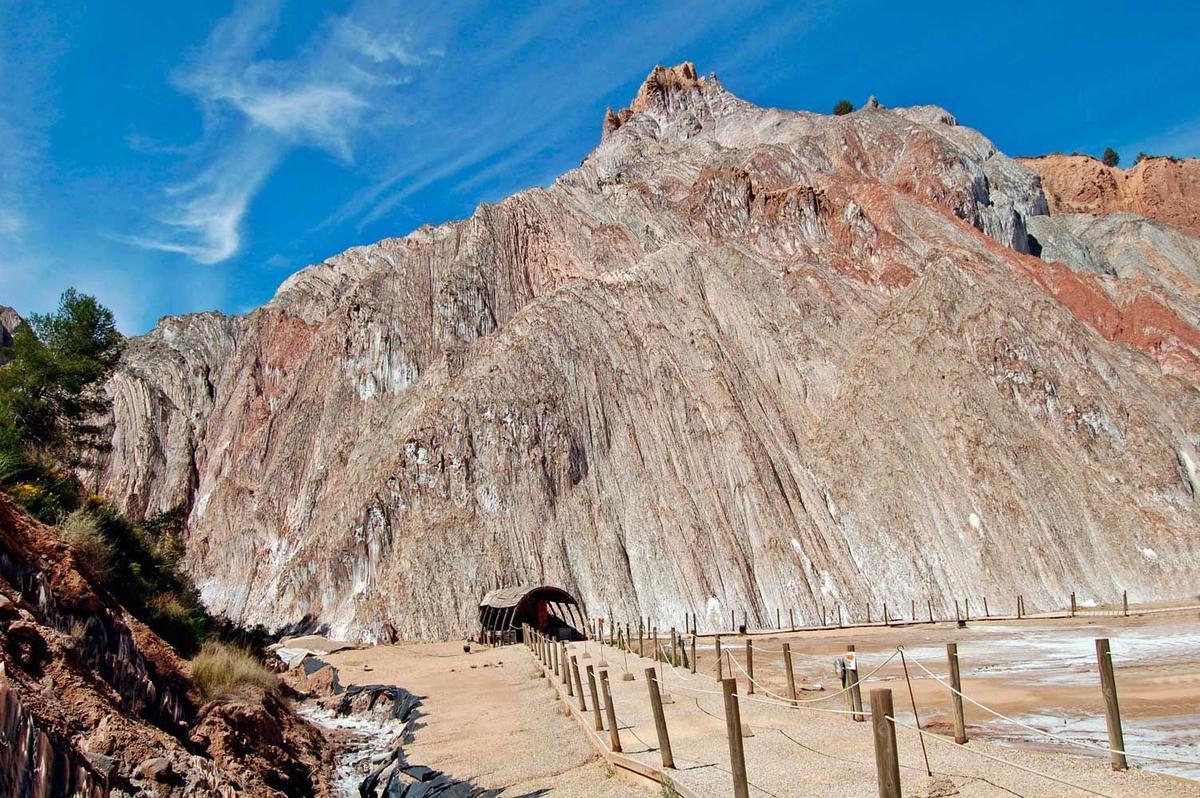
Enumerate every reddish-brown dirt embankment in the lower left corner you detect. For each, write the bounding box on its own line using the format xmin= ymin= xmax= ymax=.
xmin=0 ymin=494 xmax=330 ymax=798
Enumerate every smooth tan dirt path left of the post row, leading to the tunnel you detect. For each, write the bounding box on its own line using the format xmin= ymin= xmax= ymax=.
xmin=325 ymin=643 xmax=647 ymax=798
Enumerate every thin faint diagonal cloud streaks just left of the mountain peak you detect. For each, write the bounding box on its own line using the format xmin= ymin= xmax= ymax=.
xmin=338 ymin=5 xmax=737 ymax=230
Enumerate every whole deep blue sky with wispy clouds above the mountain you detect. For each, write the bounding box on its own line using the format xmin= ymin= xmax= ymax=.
xmin=0 ymin=0 xmax=1200 ymax=334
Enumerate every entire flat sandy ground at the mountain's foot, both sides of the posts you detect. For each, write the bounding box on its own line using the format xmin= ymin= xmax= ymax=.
xmin=328 ymin=612 xmax=1200 ymax=798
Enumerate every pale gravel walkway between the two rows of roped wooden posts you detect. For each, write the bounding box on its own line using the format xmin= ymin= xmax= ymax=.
xmin=554 ymin=628 xmax=1200 ymax=798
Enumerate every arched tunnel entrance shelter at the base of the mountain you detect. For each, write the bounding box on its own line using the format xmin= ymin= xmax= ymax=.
xmin=479 ymin=584 xmax=588 ymax=643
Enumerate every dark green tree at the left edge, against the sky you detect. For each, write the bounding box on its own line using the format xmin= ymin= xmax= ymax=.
xmin=0 ymin=288 xmax=124 ymax=466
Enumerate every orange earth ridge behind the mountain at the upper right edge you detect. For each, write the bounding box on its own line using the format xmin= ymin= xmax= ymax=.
xmin=1020 ymin=155 xmax=1200 ymax=236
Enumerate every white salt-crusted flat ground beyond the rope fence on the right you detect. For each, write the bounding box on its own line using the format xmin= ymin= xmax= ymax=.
xmin=697 ymin=611 xmax=1200 ymax=779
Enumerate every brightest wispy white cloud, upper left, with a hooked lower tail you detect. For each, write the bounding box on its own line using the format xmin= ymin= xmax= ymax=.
xmin=112 ymin=1 xmax=440 ymax=264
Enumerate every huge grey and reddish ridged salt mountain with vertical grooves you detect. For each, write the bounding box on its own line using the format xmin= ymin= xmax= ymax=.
xmin=91 ymin=64 xmax=1200 ymax=640
